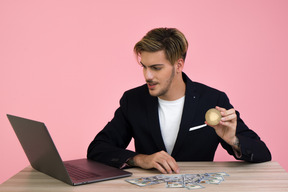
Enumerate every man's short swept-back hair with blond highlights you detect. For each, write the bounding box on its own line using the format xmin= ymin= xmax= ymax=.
xmin=134 ymin=28 xmax=188 ymax=64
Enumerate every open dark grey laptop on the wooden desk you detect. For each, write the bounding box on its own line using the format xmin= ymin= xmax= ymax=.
xmin=7 ymin=114 xmax=132 ymax=185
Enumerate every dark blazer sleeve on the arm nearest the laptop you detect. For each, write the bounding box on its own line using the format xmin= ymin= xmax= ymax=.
xmin=87 ymin=93 xmax=137 ymax=168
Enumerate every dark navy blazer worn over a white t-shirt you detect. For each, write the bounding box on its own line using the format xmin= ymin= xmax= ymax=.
xmin=87 ymin=73 xmax=271 ymax=167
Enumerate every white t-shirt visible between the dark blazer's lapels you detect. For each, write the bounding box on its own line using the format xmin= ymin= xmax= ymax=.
xmin=158 ymin=96 xmax=185 ymax=155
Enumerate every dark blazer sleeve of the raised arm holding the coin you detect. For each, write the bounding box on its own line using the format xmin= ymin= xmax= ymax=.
xmin=219 ymin=93 xmax=271 ymax=162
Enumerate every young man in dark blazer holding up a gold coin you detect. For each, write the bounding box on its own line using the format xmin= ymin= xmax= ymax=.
xmin=87 ymin=28 xmax=271 ymax=173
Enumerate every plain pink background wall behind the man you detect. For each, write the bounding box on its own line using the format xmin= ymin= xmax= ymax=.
xmin=0 ymin=0 xmax=288 ymax=183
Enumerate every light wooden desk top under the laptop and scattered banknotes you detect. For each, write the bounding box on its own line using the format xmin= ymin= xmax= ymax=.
xmin=0 ymin=161 xmax=288 ymax=192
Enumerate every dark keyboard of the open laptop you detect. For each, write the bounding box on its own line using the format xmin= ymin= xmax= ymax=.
xmin=65 ymin=163 xmax=100 ymax=180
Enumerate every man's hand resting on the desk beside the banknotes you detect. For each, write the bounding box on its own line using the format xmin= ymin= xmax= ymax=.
xmin=133 ymin=151 xmax=180 ymax=174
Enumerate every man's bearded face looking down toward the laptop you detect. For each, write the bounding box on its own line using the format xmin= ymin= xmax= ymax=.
xmin=140 ymin=51 xmax=175 ymax=100
